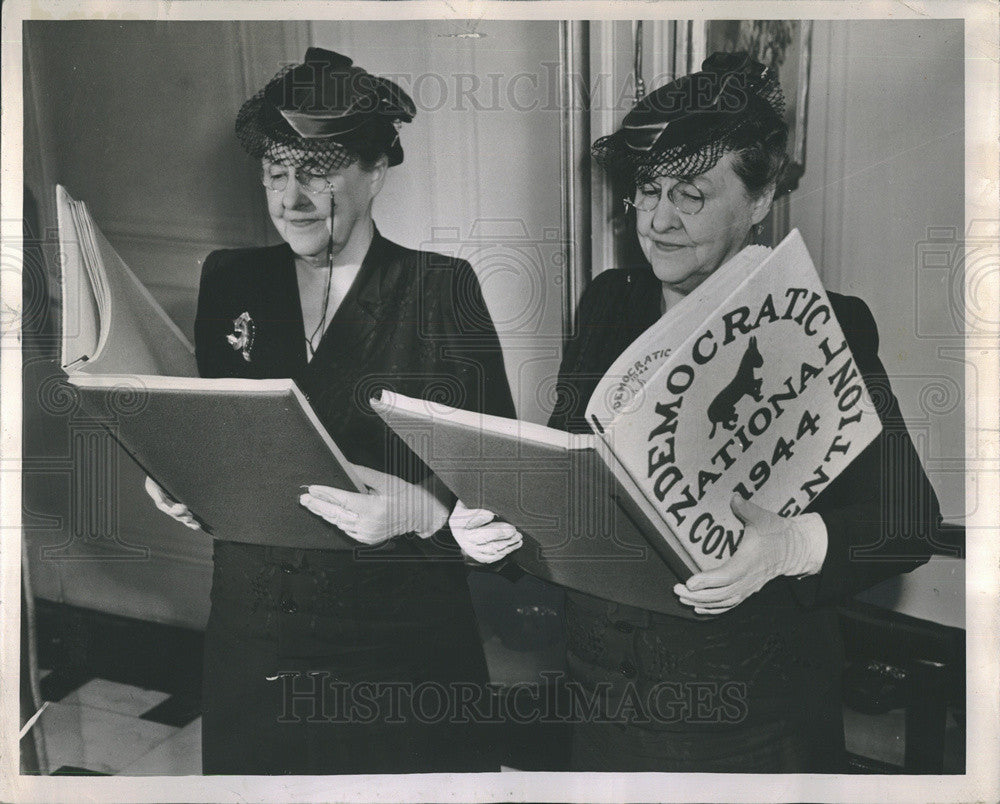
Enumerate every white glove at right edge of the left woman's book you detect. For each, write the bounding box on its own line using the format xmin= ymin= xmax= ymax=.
xmin=299 ymin=466 xmax=448 ymax=545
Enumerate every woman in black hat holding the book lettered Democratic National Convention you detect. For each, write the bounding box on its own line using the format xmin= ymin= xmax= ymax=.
xmin=452 ymin=53 xmax=940 ymax=772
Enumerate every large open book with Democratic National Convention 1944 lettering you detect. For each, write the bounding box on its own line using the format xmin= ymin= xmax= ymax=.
xmin=373 ymin=231 xmax=881 ymax=613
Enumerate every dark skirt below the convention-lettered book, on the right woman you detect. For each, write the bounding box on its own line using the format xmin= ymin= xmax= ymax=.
xmin=566 ymin=592 xmax=844 ymax=773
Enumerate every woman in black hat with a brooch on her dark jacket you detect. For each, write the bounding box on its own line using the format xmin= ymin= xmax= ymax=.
xmin=150 ymin=48 xmax=513 ymax=774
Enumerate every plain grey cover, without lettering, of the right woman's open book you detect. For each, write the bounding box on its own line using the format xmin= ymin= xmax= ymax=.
xmin=371 ymin=391 xmax=698 ymax=619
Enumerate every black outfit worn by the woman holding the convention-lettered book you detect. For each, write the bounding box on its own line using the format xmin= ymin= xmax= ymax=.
xmin=550 ymin=269 xmax=940 ymax=772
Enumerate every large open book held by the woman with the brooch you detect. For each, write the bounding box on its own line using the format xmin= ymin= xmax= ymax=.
xmin=56 ymin=187 xmax=364 ymax=549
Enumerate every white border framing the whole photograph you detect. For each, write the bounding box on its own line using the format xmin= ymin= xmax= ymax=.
xmin=0 ymin=0 xmax=1000 ymax=802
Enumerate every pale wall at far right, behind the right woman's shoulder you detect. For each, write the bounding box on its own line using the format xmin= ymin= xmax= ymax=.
xmin=790 ymin=20 xmax=964 ymax=625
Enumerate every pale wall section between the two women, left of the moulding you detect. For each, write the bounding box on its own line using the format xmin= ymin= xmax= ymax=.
xmin=310 ymin=20 xmax=564 ymax=424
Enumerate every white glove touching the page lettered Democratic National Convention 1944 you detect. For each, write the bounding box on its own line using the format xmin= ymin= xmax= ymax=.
xmin=674 ymin=494 xmax=827 ymax=614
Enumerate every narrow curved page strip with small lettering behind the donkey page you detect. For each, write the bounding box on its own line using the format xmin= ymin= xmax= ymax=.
xmin=586 ymin=246 xmax=771 ymax=430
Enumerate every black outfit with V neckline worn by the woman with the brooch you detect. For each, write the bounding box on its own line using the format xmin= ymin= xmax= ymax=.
xmin=195 ymin=232 xmax=513 ymax=774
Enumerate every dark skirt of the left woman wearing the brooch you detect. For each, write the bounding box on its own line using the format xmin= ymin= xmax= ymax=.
xmin=202 ymin=542 xmax=498 ymax=774
